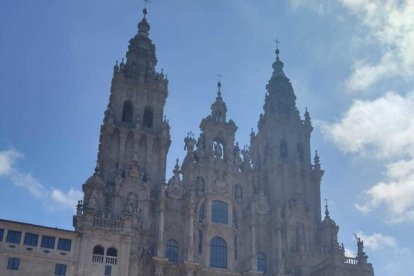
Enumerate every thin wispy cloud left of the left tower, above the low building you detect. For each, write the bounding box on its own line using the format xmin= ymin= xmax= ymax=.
xmin=0 ymin=149 xmax=82 ymax=209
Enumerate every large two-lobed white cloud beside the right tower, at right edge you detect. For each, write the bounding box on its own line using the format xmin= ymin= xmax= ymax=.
xmin=322 ymin=92 xmax=414 ymax=222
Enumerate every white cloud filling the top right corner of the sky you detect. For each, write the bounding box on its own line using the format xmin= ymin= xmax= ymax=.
xmin=339 ymin=0 xmax=414 ymax=91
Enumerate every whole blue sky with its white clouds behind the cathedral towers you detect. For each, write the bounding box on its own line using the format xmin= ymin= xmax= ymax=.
xmin=0 ymin=0 xmax=414 ymax=275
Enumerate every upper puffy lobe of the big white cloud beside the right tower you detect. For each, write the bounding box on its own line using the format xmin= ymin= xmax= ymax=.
xmin=322 ymin=92 xmax=414 ymax=159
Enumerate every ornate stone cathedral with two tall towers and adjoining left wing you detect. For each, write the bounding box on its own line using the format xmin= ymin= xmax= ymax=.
xmin=0 ymin=7 xmax=374 ymax=276
